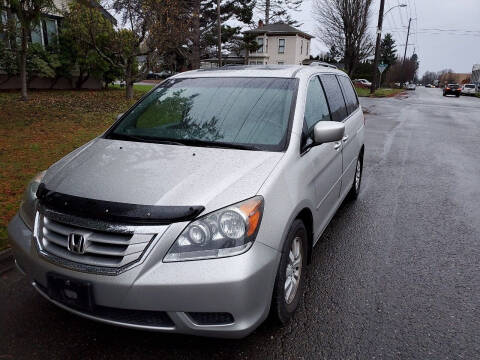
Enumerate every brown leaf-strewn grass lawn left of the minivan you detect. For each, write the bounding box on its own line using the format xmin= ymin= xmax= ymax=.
xmin=0 ymin=85 xmax=146 ymax=250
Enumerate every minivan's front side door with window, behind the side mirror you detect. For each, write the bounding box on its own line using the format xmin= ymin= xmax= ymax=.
xmin=302 ymin=76 xmax=342 ymax=235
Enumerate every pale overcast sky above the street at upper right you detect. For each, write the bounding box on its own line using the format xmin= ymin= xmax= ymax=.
xmin=292 ymin=0 xmax=480 ymax=76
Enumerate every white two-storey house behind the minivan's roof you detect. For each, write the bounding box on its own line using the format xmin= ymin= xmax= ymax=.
xmin=245 ymin=20 xmax=314 ymax=65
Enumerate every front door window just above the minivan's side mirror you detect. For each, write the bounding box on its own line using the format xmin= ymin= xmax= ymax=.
xmin=304 ymin=76 xmax=330 ymax=132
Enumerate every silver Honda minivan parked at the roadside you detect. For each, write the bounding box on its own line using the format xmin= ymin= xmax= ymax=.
xmin=8 ymin=66 xmax=364 ymax=338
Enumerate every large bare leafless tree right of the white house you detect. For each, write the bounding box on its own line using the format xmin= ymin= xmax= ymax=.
xmin=313 ymin=0 xmax=373 ymax=75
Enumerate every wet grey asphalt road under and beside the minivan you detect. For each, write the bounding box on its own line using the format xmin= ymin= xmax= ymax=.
xmin=0 ymin=88 xmax=480 ymax=359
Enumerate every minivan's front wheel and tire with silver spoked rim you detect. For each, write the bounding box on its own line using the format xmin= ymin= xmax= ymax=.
xmin=270 ymin=219 xmax=308 ymax=325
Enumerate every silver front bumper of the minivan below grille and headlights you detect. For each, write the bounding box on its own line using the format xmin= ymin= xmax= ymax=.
xmin=8 ymin=215 xmax=280 ymax=338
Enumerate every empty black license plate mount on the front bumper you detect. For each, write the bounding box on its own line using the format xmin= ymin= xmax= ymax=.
xmin=47 ymin=274 xmax=94 ymax=311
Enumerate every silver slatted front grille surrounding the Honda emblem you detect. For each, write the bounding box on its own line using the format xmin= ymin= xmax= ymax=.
xmin=37 ymin=215 xmax=160 ymax=268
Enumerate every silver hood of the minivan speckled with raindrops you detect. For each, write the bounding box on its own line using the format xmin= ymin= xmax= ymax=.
xmin=43 ymin=138 xmax=283 ymax=211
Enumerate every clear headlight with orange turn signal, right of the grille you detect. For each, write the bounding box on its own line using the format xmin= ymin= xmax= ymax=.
xmin=163 ymin=196 xmax=263 ymax=262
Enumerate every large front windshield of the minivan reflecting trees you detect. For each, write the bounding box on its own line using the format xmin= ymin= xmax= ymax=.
xmin=106 ymin=78 xmax=296 ymax=151
